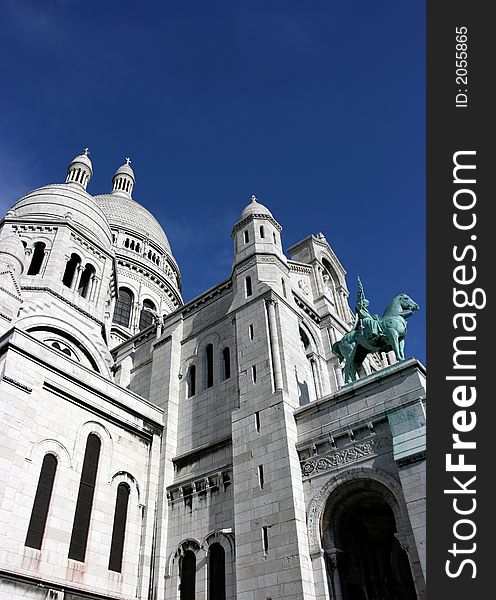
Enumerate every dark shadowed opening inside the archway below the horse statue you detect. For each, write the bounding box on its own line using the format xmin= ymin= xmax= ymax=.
xmin=323 ymin=487 xmax=417 ymax=600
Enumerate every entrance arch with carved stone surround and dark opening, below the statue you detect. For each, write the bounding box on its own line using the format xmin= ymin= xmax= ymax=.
xmin=307 ymin=466 xmax=424 ymax=600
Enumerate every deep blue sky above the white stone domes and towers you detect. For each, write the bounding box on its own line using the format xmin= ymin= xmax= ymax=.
xmin=0 ymin=0 xmax=425 ymax=361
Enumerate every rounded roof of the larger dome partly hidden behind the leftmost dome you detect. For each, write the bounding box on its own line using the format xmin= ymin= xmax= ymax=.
xmin=94 ymin=193 xmax=172 ymax=254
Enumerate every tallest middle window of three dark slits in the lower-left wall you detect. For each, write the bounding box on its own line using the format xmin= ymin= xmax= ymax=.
xmin=69 ymin=433 xmax=101 ymax=562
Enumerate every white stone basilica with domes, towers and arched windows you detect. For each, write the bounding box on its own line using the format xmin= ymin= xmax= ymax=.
xmin=0 ymin=150 xmax=425 ymax=600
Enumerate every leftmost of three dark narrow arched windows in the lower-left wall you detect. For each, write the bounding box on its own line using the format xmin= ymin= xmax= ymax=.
xmin=25 ymin=454 xmax=57 ymax=550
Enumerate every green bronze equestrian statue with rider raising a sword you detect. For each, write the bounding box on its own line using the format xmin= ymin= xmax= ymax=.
xmin=332 ymin=277 xmax=419 ymax=383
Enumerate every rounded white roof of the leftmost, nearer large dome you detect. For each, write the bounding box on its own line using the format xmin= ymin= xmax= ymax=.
xmin=11 ymin=183 xmax=112 ymax=247
